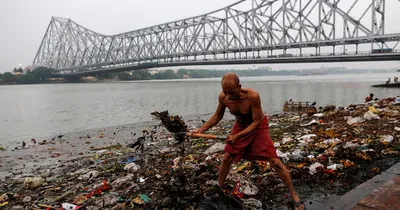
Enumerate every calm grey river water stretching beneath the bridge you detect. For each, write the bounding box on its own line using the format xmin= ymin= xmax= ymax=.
xmin=0 ymin=73 xmax=400 ymax=145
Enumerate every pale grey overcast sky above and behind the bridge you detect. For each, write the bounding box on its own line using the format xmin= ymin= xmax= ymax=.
xmin=0 ymin=0 xmax=400 ymax=72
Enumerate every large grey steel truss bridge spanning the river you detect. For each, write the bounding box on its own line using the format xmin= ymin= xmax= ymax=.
xmin=33 ymin=0 xmax=400 ymax=76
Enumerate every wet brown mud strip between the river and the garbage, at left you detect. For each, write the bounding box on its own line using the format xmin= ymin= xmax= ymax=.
xmin=0 ymin=113 xmax=225 ymax=181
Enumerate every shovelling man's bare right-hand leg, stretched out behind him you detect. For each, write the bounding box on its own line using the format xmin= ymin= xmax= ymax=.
xmin=269 ymin=158 xmax=305 ymax=209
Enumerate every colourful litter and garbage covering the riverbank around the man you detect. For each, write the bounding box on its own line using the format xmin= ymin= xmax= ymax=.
xmin=0 ymin=96 xmax=400 ymax=210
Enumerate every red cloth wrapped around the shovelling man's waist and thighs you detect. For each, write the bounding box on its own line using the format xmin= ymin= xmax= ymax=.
xmin=224 ymin=117 xmax=278 ymax=163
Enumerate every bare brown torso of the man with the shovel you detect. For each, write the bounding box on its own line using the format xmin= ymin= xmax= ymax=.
xmin=219 ymin=88 xmax=262 ymax=126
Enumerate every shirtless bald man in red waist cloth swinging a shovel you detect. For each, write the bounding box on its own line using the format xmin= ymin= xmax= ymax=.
xmin=193 ymin=73 xmax=305 ymax=210
